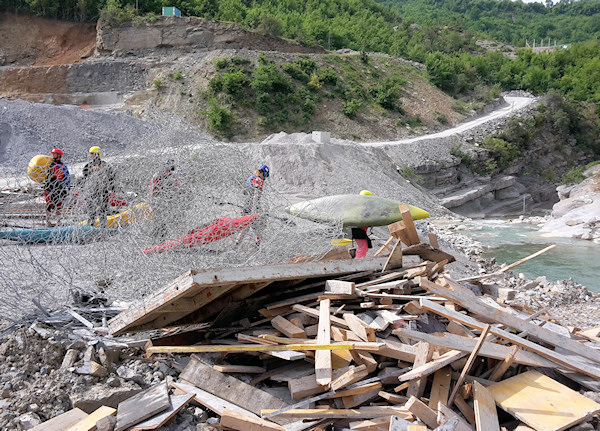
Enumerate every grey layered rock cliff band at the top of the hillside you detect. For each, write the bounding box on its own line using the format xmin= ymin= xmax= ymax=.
xmin=96 ymin=16 xmax=325 ymax=53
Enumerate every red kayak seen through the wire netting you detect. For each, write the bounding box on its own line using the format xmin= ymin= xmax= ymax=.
xmin=142 ymin=214 xmax=258 ymax=253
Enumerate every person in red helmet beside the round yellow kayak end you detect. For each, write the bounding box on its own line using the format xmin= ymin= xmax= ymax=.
xmin=44 ymin=148 xmax=71 ymax=226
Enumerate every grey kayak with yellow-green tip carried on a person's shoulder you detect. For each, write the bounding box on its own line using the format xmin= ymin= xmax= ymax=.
xmin=287 ymin=194 xmax=429 ymax=227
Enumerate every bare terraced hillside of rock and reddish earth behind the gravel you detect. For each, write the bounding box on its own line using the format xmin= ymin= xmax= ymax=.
xmin=0 ymin=13 xmax=469 ymax=141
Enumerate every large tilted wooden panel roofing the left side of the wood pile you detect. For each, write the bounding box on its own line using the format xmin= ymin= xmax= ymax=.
xmin=108 ymin=259 xmax=384 ymax=335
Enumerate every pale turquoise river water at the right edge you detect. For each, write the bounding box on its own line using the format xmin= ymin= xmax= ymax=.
xmin=461 ymin=220 xmax=600 ymax=292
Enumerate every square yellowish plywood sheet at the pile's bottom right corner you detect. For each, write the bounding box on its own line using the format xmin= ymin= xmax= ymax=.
xmin=488 ymin=371 xmax=600 ymax=431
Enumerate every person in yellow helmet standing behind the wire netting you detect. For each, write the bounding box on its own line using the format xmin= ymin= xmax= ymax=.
xmin=83 ymin=146 xmax=115 ymax=227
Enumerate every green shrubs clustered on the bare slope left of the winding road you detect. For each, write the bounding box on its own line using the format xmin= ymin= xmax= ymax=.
xmin=203 ymin=55 xmax=411 ymax=130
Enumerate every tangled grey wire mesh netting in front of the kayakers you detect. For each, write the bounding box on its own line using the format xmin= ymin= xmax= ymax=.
xmin=0 ymin=137 xmax=342 ymax=317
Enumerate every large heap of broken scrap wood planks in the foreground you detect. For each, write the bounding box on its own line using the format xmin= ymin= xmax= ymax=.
xmin=30 ymin=208 xmax=600 ymax=431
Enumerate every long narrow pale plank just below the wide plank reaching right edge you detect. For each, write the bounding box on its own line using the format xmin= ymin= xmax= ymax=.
xmin=421 ymin=299 xmax=600 ymax=378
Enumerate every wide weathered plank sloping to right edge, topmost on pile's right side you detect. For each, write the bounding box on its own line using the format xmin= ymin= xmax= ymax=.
xmin=419 ymin=277 xmax=600 ymax=363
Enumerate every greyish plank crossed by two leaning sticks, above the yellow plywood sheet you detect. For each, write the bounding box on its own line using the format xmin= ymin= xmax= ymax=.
xmin=393 ymin=330 xmax=556 ymax=368
